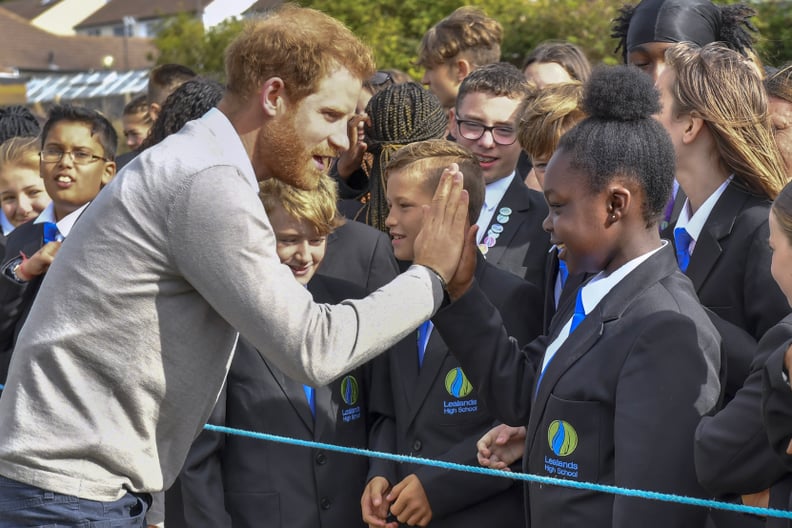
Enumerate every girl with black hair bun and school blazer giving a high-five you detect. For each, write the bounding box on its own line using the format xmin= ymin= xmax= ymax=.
xmin=432 ymin=66 xmax=720 ymax=528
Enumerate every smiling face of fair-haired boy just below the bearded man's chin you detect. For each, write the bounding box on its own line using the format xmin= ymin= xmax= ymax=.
xmin=268 ymin=206 xmax=327 ymax=286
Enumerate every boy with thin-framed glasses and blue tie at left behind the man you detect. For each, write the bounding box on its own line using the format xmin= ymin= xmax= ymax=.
xmin=0 ymin=106 xmax=118 ymax=368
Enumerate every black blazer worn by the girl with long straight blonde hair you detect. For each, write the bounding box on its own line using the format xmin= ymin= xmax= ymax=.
xmin=664 ymin=181 xmax=789 ymax=400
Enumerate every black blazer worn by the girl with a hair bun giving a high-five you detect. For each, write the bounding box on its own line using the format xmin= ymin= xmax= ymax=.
xmin=434 ymin=246 xmax=720 ymax=528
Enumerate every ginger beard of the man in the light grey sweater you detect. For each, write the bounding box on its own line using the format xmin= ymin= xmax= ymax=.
xmin=255 ymin=110 xmax=334 ymax=190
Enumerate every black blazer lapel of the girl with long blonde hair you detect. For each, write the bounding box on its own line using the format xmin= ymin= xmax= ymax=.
xmin=685 ymin=182 xmax=748 ymax=292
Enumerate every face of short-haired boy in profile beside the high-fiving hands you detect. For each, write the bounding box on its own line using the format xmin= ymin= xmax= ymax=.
xmin=385 ymin=167 xmax=434 ymax=261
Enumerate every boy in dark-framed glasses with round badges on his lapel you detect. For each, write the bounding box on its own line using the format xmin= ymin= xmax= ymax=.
xmin=451 ymin=62 xmax=550 ymax=288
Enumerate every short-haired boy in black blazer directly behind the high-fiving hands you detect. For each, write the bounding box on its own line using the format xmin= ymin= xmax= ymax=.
xmin=362 ymin=140 xmax=542 ymax=528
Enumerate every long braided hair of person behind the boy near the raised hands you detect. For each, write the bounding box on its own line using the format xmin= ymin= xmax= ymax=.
xmin=359 ymin=82 xmax=448 ymax=232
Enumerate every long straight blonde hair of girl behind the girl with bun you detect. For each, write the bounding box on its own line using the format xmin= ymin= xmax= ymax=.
xmin=666 ymin=42 xmax=786 ymax=199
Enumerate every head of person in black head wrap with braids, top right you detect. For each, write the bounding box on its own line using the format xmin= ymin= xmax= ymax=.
xmin=611 ymin=0 xmax=761 ymax=80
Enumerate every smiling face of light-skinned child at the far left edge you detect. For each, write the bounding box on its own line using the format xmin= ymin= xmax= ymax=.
xmin=0 ymin=165 xmax=50 ymax=227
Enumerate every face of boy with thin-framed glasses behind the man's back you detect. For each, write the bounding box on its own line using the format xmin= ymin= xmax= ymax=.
xmin=40 ymin=121 xmax=115 ymax=220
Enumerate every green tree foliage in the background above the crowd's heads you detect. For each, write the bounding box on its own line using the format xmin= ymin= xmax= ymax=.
xmin=155 ymin=0 xmax=792 ymax=79
